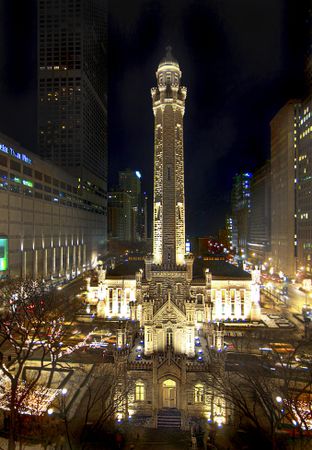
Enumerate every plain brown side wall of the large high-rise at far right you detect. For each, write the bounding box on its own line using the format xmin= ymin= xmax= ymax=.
xmin=271 ymin=100 xmax=301 ymax=276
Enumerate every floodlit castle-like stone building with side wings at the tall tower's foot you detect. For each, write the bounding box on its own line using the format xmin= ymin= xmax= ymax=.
xmin=86 ymin=255 xmax=260 ymax=429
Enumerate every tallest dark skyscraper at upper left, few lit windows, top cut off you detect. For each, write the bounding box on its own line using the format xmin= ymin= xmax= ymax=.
xmin=38 ymin=0 xmax=107 ymax=248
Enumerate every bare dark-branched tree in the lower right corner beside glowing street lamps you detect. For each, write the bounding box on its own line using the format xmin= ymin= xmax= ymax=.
xmin=207 ymin=344 xmax=312 ymax=449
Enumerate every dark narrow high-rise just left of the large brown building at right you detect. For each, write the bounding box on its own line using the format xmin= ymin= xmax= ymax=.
xmin=248 ymin=161 xmax=271 ymax=264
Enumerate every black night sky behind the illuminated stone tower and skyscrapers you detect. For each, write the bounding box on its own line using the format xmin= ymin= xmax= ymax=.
xmin=0 ymin=0 xmax=311 ymax=235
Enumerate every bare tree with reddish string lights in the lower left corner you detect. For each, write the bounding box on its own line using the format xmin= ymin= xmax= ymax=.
xmin=0 ymin=280 xmax=81 ymax=450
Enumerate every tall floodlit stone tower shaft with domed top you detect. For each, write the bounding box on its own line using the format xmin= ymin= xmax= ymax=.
xmin=151 ymin=47 xmax=186 ymax=265
